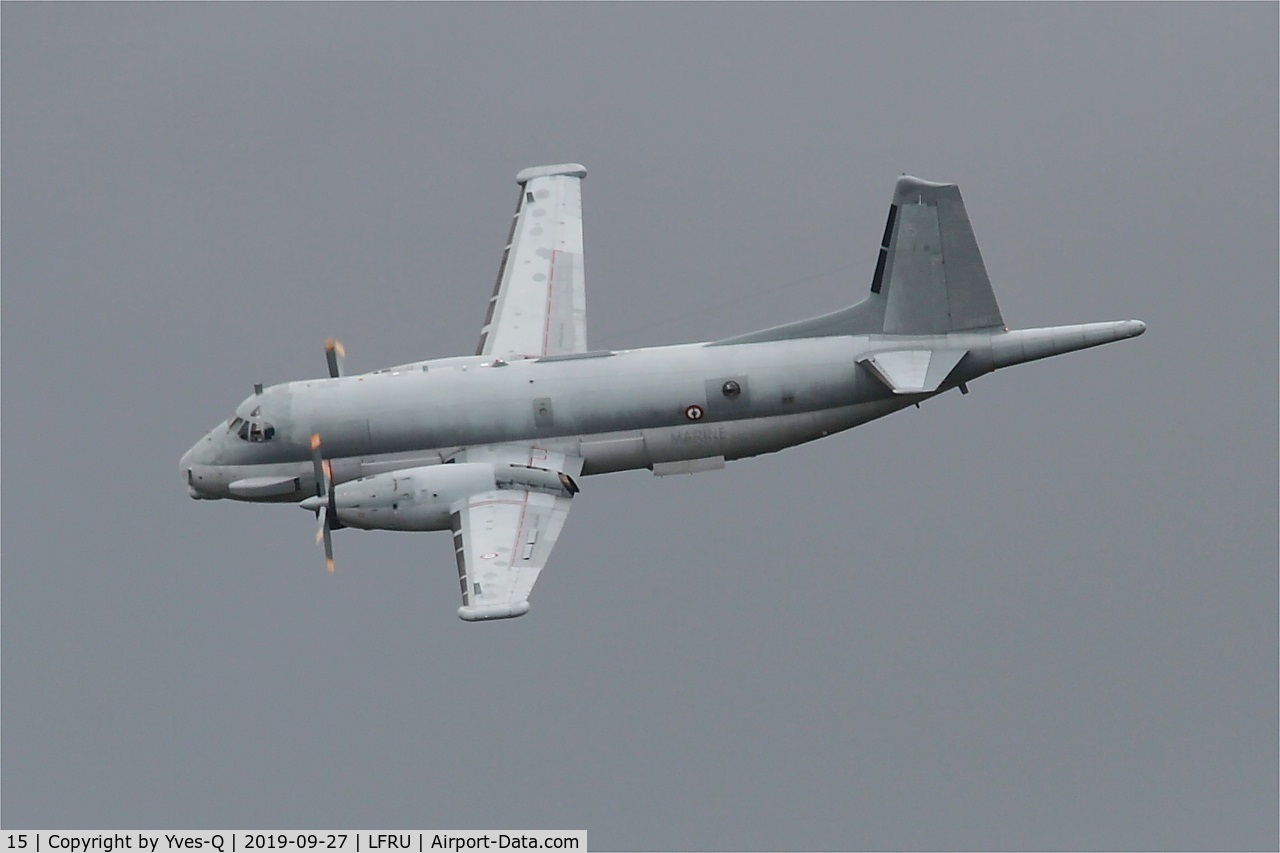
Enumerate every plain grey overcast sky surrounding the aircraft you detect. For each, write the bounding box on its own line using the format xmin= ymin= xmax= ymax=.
xmin=0 ymin=3 xmax=1280 ymax=849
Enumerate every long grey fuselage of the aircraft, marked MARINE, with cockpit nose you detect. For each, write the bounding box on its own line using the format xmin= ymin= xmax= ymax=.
xmin=182 ymin=334 xmax=967 ymax=502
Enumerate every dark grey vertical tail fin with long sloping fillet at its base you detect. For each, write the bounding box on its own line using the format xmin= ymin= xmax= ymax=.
xmin=716 ymin=175 xmax=1005 ymax=343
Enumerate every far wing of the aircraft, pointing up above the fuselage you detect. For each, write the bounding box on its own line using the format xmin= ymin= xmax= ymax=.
xmin=476 ymin=163 xmax=586 ymax=359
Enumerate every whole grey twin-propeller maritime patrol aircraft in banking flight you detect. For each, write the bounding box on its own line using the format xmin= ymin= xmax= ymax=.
xmin=180 ymin=163 xmax=1147 ymax=621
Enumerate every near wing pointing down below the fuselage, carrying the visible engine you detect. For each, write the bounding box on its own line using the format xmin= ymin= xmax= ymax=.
xmin=452 ymin=446 xmax=582 ymax=621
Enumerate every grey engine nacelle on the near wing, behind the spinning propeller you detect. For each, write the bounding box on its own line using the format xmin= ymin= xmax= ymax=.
xmin=333 ymin=462 xmax=577 ymax=530
